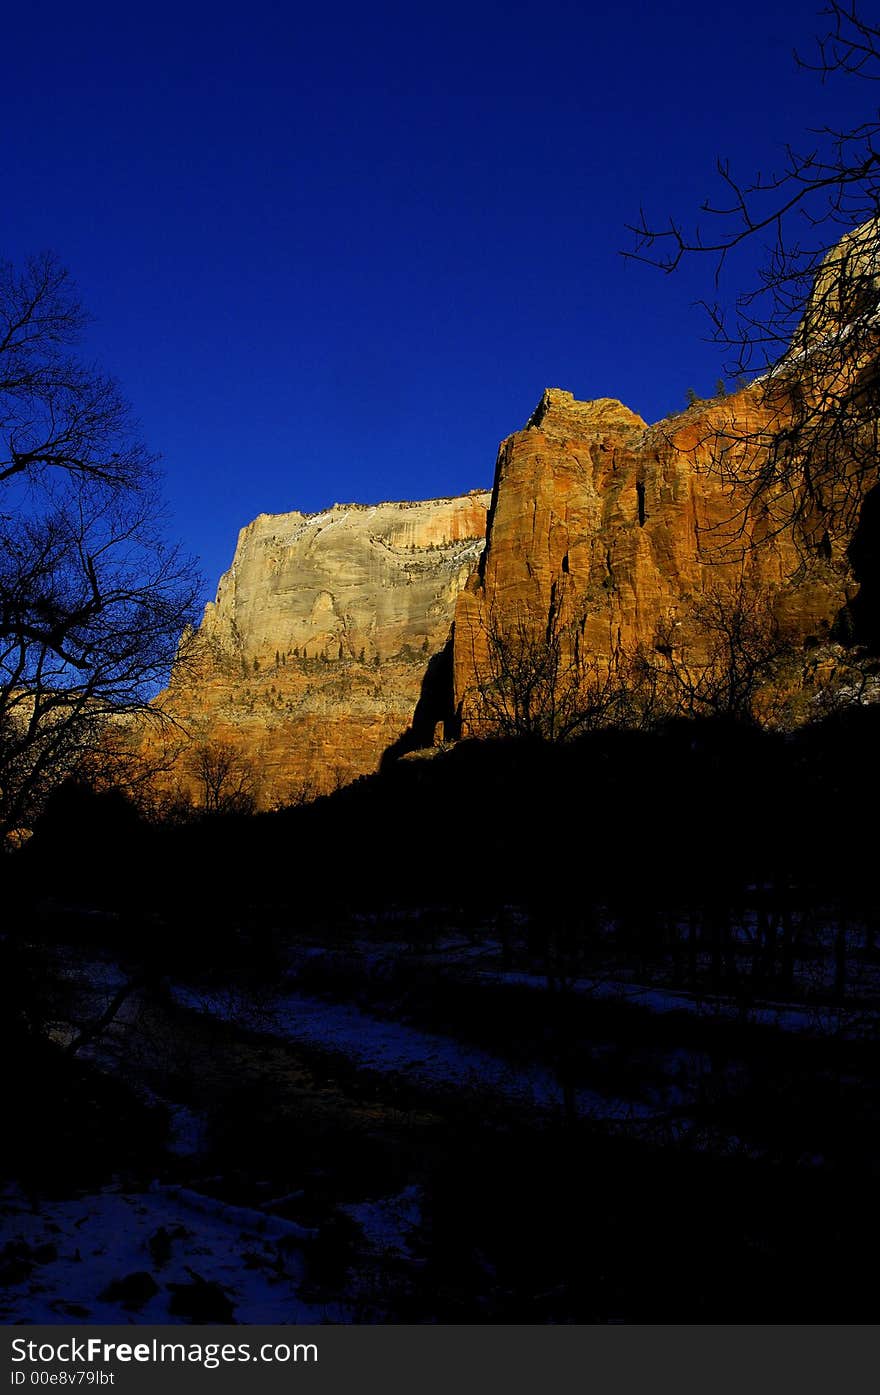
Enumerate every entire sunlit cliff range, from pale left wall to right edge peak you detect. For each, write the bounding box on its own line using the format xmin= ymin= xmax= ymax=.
xmin=151 ymin=223 xmax=880 ymax=805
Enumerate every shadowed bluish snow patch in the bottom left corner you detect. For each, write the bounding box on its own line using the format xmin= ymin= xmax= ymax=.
xmin=0 ymin=1187 xmax=337 ymax=1324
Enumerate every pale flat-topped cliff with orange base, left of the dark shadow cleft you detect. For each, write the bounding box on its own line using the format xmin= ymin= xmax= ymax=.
xmin=159 ymin=491 xmax=490 ymax=806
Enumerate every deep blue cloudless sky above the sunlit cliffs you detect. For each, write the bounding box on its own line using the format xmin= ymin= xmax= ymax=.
xmin=0 ymin=0 xmax=874 ymax=593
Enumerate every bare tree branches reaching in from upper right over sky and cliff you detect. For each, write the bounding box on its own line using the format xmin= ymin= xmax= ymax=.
xmin=625 ymin=0 xmax=880 ymax=557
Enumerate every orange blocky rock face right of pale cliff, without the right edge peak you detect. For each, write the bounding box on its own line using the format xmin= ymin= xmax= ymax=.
xmin=453 ymin=386 xmax=852 ymax=732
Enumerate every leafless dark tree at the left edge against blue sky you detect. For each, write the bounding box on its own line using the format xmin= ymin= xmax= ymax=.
xmin=0 ymin=252 xmax=197 ymax=836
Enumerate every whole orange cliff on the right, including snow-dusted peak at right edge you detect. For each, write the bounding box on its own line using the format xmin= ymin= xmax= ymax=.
xmin=453 ymin=219 xmax=880 ymax=731
